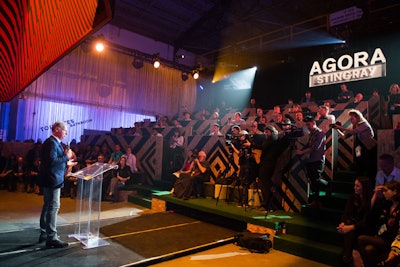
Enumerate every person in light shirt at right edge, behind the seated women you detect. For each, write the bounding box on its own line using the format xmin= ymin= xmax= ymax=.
xmin=375 ymin=154 xmax=400 ymax=187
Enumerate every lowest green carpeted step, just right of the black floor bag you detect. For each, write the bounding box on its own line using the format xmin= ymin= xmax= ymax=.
xmin=274 ymin=234 xmax=342 ymax=266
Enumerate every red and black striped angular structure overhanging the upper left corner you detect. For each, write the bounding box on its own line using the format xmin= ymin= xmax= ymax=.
xmin=0 ymin=0 xmax=111 ymax=102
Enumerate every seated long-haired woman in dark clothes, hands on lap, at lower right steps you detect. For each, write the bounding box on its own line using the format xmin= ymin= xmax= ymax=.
xmin=336 ymin=176 xmax=372 ymax=267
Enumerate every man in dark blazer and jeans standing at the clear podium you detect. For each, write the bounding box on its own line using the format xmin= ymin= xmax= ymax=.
xmin=39 ymin=122 xmax=76 ymax=248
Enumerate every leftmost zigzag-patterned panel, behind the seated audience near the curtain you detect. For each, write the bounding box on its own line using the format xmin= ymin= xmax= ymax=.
xmin=82 ymin=135 xmax=163 ymax=180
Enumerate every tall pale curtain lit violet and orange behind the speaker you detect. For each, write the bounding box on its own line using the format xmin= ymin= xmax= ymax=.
xmin=16 ymin=47 xmax=196 ymax=141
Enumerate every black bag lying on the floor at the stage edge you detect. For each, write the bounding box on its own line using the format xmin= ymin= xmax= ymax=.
xmin=234 ymin=232 xmax=272 ymax=253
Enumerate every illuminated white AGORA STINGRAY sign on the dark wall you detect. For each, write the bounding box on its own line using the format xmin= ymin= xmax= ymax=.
xmin=309 ymin=48 xmax=386 ymax=87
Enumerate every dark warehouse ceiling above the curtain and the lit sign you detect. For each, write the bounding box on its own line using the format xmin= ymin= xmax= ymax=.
xmin=111 ymin=0 xmax=400 ymax=59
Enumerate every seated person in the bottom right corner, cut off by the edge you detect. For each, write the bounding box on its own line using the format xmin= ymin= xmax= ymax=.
xmin=357 ymin=181 xmax=400 ymax=267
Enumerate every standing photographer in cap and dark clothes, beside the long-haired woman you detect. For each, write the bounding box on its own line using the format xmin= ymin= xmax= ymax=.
xmin=295 ymin=116 xmax=326 ymax=208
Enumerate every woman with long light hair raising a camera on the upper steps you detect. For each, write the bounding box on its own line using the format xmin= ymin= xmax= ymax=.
xmin=332 ymin=109 xmax=377 ymax=181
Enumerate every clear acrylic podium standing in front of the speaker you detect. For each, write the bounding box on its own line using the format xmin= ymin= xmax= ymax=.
xmin=68 ymin=163 xmax=118 ymax=249
